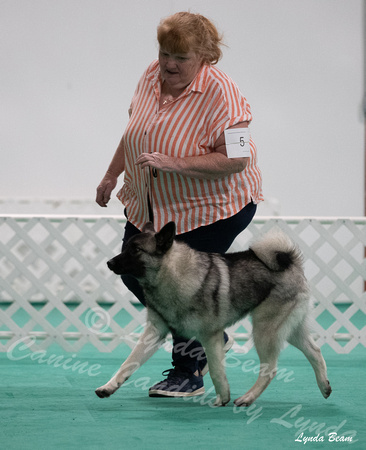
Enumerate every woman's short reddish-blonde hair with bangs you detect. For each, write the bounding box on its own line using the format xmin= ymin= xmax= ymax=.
xmin=157 ymin=12 xmax=223 ymax=64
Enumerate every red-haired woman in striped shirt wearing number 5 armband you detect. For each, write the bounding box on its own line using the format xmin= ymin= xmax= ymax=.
xmin=96 ymin=12 xmax=263 ymax=397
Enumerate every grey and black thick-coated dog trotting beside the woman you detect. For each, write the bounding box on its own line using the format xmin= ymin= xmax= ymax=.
xmin=95 ymin=222 xmax=332 ymax=406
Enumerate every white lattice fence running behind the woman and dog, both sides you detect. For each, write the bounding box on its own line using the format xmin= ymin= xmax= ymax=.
xmin=0 ymin=216 xmax=366 ymax=353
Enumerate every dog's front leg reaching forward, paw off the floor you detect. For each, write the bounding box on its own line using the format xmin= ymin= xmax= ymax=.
xmin=95 ymin=320 xmax=167 ymax=398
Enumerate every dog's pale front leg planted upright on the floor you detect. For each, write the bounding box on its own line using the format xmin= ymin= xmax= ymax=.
xmin=202 ymin=331 xmax=230 ymax=406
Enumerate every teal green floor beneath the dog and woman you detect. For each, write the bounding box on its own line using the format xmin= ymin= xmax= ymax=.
xmin=0 ymin=345 xmax=366 ymax=450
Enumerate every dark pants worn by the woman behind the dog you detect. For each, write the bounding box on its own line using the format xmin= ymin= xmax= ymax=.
xmin=121 ymin=203 xmax=257 ymax=373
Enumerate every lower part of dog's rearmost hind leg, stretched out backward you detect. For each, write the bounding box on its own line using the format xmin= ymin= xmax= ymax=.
xmin=287 ymin=323 xmax=332 ymax=398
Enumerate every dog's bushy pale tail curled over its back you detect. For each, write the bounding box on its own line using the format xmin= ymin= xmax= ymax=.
xmin=250 ymin=229 xmax=303 ymax=272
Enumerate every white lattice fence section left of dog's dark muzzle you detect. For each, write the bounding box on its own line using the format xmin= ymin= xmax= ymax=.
xmin=0 ymin=217 xmax=145 ymax=351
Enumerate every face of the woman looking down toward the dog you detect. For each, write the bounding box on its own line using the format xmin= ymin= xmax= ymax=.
xmin=159 ymin=48 xmax=202 ymax=90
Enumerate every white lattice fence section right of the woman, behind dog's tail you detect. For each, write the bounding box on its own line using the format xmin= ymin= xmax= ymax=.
xmin=230 ymin=218 xmax=366 ymax=353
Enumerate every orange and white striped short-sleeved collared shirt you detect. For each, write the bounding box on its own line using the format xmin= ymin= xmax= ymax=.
xmin=117 ymin=61 xmax=263 ymax=234
